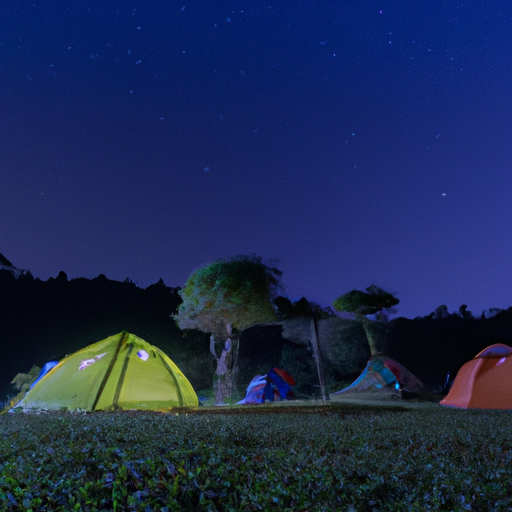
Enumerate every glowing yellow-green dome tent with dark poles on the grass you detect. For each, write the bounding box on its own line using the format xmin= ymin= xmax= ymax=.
xmin=16 ymin=331 xmax=198 ymax=411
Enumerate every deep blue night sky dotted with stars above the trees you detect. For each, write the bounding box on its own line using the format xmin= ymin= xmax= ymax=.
xmin=0 ymin=0 xmax=512 ymax=318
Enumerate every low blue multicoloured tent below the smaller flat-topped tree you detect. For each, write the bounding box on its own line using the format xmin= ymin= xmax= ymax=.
xmin=330 ymin=356 xmax=427 ymax=400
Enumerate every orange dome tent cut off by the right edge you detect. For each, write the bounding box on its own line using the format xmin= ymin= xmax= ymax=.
xmin=440 ymin=343 xmax=512 ymax=409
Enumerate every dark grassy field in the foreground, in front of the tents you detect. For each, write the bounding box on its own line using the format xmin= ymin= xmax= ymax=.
xmin=0 ymin=405 xmax=512 ymax=512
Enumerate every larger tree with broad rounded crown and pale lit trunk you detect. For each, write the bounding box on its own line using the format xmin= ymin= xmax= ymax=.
xmin=173 ymin=254 xmax=282 ymax=403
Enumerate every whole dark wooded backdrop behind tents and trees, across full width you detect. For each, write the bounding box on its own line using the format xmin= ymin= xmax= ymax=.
xmin=0 ymin=270 xmax=512 ymax=401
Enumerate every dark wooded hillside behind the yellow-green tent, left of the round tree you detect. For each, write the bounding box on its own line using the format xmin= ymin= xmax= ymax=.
xmin=0 ymin=271 xmax=213 ymax=395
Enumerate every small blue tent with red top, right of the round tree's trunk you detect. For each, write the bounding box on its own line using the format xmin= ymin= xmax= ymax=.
xmin=238 ymin=368 xmax=295 ymax=405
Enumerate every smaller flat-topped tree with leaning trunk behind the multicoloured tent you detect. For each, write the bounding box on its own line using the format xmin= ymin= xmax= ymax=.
xmin=332 ymin=285 xmax=400 ymax=357
